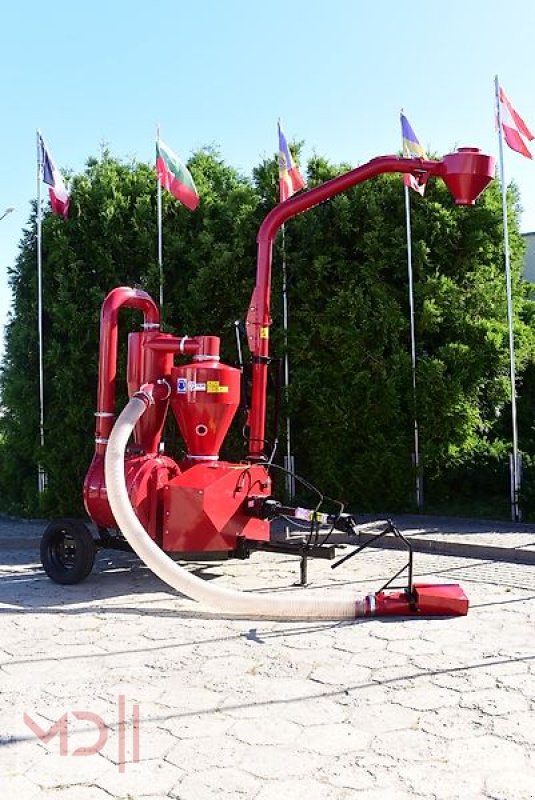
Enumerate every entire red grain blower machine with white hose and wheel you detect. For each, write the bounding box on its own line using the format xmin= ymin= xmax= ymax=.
xmin=41 ymin=148 xmax=494 ymax=617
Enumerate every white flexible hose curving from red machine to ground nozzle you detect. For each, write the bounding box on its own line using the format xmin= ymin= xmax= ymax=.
xmin=104 ymin=397 xmax=371 ymax=619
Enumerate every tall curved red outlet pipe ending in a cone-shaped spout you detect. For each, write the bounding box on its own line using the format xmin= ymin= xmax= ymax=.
xmin=248 ymin=147 xmax=495 ymax=460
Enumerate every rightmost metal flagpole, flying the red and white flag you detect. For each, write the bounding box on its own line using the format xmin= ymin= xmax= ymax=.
xmin=494 ymin=75 xmax=521 ymax=522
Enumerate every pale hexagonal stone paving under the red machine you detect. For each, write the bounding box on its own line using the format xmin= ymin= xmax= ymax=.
xmin=0 ymin=519 xmax=535 ymax=800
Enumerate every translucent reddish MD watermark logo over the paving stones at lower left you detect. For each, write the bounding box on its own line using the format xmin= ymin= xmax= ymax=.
xmin=24 ymin=694 xmax=139 ymax=772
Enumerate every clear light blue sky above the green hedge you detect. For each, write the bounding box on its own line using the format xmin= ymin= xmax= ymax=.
xmin=0 ymin=0 xmax=535 ymax=358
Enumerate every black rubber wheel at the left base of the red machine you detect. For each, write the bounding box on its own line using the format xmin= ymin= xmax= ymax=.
xmin=41 ymin=519 xmax=96 ymax=585
